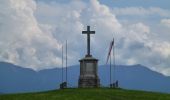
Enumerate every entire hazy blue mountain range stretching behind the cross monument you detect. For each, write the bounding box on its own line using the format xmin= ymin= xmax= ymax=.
xmin=0 ymin=62 xmax=170 ymax=93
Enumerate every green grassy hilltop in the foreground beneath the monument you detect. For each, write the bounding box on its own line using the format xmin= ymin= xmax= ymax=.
xmin=0 ymin=88 xmax=170 ymax=100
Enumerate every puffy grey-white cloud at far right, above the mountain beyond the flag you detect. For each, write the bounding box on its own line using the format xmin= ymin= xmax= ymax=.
xmin=116 ymin=22 xmax=170 ymax=75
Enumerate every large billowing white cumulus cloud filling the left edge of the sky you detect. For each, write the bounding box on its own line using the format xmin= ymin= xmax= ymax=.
xmin=0 ymin=0 xmax=60 ymax=69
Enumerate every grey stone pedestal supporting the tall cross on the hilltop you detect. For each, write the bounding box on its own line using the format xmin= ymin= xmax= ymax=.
xmin=78 ymin=56 xmax=100 ymax=88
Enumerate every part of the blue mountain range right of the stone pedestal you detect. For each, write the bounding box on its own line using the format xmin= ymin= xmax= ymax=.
xmin=99 ymin=64 xmax=170 ymax=93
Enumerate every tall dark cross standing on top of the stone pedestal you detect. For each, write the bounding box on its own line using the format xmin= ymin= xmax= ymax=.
xmin=82 ymin=26 xmax=95 ymax=56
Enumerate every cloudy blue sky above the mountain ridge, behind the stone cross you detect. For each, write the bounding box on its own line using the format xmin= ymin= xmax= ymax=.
xmin=0 ymin=0 xmax=170 ymax=76
